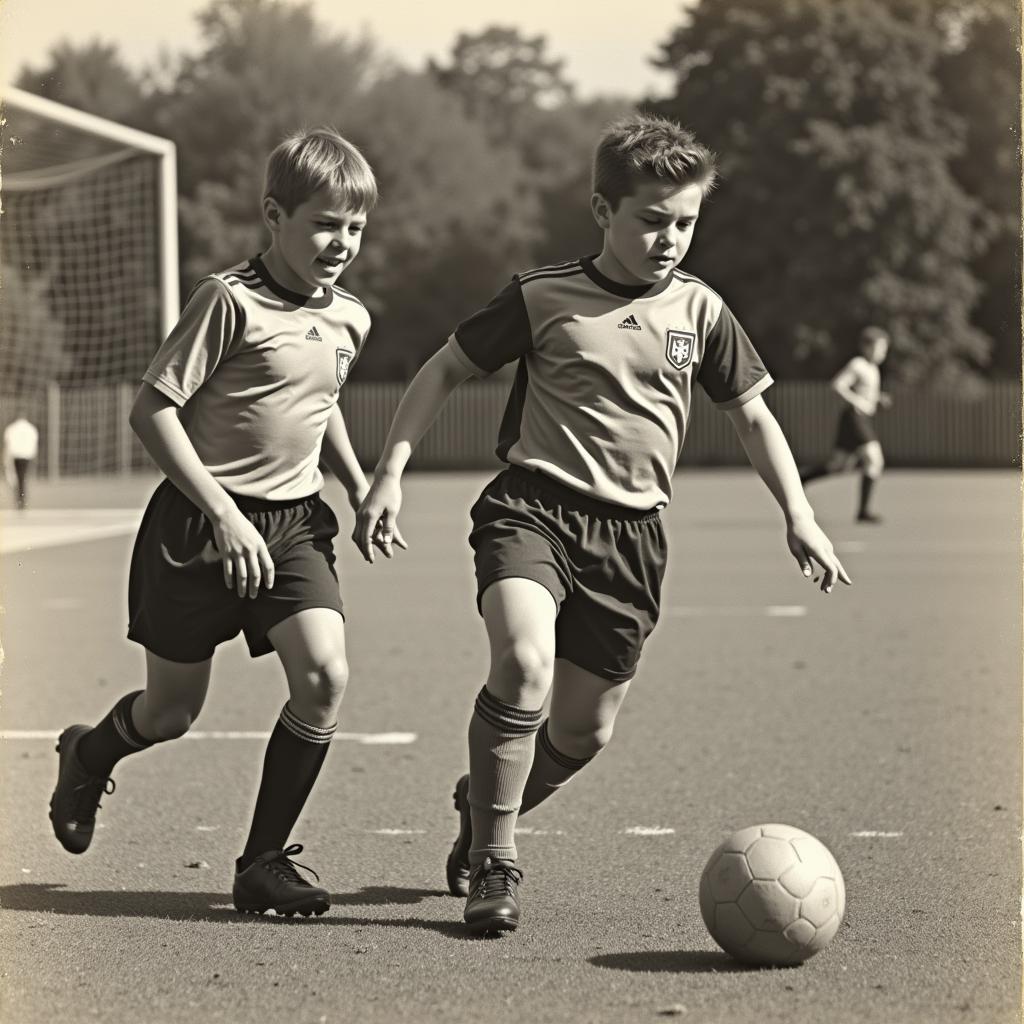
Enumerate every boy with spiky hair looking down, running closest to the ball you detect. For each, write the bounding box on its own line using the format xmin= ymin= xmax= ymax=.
xmin=353 ymin=116 xmax=850 ymax=933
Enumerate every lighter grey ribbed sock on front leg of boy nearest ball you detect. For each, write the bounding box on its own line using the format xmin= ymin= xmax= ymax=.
xmin=469 ymin=687 xmax=544 ymax=864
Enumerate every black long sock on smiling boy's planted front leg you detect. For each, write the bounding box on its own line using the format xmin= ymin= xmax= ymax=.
xmin=238 ymin=703 xmax=337 ymax=871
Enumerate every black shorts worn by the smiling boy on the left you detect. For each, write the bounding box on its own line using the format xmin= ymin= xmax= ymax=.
xmin=128 ymin=480 xmax=342 ymax=663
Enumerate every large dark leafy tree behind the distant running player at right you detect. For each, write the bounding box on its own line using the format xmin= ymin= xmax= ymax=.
xmin=657 ymin=0 xmax=990 ymax=384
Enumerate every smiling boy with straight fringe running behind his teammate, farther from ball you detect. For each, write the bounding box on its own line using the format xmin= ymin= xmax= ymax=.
xmin=50 ymin=129 xmax=400 ymax=915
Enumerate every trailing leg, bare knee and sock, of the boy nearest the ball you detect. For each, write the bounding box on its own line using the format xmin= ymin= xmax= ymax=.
xmin=519 ymin=658 xmax=630 ymax=815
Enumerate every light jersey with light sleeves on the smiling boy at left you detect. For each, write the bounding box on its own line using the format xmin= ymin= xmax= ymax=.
xmin=142 ymin=257 xmax=370 ymax=501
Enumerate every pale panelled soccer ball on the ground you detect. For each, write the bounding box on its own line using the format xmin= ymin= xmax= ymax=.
xmin=700 ymin=824 xmax=846 ymax=967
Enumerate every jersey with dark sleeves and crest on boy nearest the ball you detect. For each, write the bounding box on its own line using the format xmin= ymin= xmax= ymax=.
xmin=449 ymin=257 xmax=772 ymax=509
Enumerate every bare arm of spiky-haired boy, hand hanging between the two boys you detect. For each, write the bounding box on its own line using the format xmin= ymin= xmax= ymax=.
xmin=352 ymin=345 xmax=470 ymax=562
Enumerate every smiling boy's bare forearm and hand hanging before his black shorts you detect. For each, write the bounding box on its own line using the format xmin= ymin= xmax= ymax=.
xmin=128 ymin=384 xmax=273 ymax=597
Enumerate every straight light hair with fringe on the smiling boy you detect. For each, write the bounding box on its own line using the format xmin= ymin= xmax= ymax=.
xmin=263 ymin=128 xmax=377 ymax=214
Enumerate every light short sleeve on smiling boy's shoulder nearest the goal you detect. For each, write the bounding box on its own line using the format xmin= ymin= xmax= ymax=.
xmin=142 ymin=278 xmax=244 ymax=406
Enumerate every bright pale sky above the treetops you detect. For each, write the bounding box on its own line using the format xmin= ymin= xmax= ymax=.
xmin=0 ymin=0 xmax=685 ymax=98
